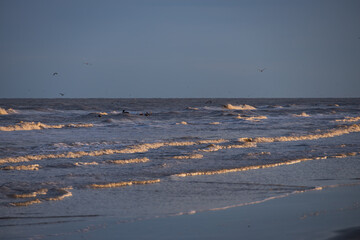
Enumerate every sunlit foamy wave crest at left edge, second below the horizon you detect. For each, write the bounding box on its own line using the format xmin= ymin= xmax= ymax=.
xmin=0 ymin=121 xmax=93 ymax=132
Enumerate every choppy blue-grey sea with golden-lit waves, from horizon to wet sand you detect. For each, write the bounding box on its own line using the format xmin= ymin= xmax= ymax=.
xmin=0 ymin=98 xmax=360 ymax=239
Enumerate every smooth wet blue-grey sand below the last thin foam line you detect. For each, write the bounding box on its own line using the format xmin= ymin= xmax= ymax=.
xmin=59 ymin=185 xmax=360 ymax=240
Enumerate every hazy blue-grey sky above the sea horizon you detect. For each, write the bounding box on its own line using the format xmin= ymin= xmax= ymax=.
xmin=0 ymin=0 xmax=360 ymax=98
